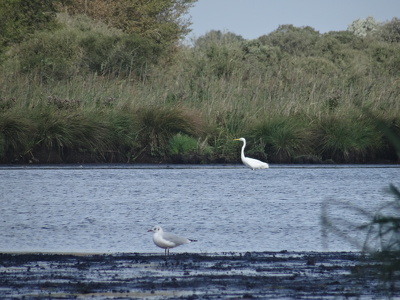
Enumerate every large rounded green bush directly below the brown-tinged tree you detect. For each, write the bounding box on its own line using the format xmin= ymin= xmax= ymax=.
xmin=14 ymin=15 xmax=161 ymax=80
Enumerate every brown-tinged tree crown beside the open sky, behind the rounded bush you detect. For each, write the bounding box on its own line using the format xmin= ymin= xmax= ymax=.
xmin=61 ymin=0 xmax=196 ymax=47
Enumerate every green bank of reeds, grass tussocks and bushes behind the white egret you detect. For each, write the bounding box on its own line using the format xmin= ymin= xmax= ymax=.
xmin=0 ymin=0 xmax=400 ymax=163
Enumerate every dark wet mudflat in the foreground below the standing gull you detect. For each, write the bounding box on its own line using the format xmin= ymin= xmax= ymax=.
xmin=0 ymin=252 xmax=400 ymax=299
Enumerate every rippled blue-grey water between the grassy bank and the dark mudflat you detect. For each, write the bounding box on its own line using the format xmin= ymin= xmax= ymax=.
xmin=0 ymin=165 xmax=400 ymax=253
